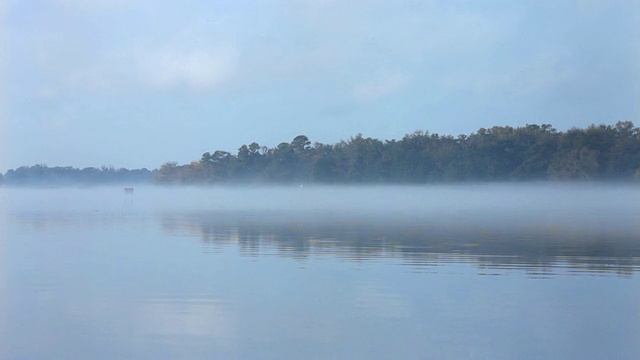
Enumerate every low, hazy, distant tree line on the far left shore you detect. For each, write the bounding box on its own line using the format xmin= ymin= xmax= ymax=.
xmin=0 ymin=164 xmax=155 ymax=185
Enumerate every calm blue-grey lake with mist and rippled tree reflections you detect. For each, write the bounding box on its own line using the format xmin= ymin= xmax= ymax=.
xmin=0 ymin=183 xmax=640 ymax=359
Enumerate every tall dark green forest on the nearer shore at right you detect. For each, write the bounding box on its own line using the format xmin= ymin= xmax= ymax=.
xmin=154 ymin=121 xmax=640 ymax=184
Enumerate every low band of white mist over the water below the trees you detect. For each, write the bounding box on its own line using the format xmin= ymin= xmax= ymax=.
xmin=6 ymin=182 xmax=640 ymax=219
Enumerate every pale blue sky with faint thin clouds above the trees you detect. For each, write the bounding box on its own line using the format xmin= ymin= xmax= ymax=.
xmin=0 ymin=0 xmax=640 ymax=172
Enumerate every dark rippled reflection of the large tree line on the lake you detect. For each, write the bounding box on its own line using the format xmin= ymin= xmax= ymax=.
xmin=159 ymin=211 xmax=640 ymax=277
